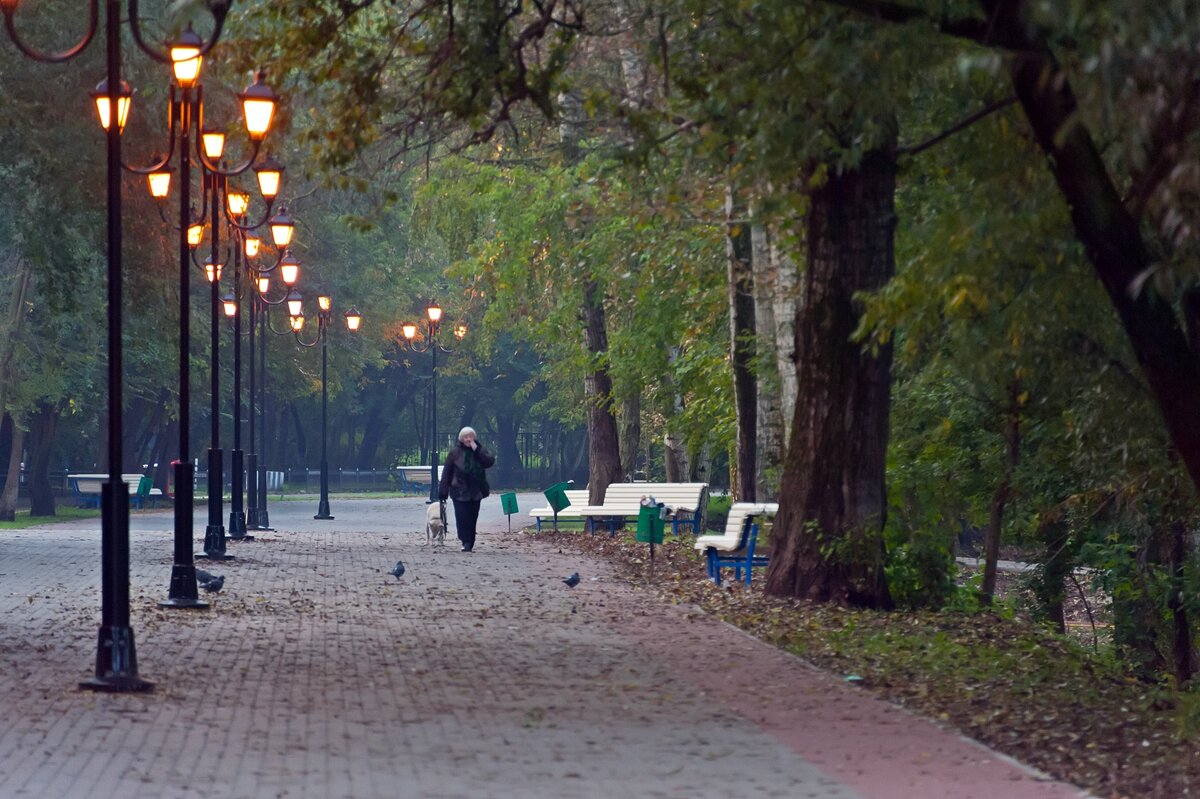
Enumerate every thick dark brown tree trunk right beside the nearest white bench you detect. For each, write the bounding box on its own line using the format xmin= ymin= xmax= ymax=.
xmin=766 ymin=148 xmax=896 ymax=608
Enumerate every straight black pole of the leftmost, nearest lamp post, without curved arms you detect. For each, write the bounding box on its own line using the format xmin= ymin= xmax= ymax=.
xmin=79 ymin=0 xmax=154 ymax=692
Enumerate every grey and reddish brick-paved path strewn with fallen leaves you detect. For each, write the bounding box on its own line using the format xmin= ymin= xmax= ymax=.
xmin=0 ymin=497 xmax=1081 ymax=799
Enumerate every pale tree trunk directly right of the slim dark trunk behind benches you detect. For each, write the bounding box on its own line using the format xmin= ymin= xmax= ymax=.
xmin=750 ymin=214 xmax=784 ymax=501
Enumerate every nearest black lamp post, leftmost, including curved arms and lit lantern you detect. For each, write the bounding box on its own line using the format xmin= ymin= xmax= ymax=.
xmin=0 ymin=0 xmax=238 ymax=692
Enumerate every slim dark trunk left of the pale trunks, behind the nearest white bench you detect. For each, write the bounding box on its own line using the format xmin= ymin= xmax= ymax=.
xmin=725 ymin=186 xmax=758 ymax=503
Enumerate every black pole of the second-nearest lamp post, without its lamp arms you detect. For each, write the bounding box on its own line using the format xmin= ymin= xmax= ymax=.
xmin=158 ymin=88 xmax=209 ymax=608
